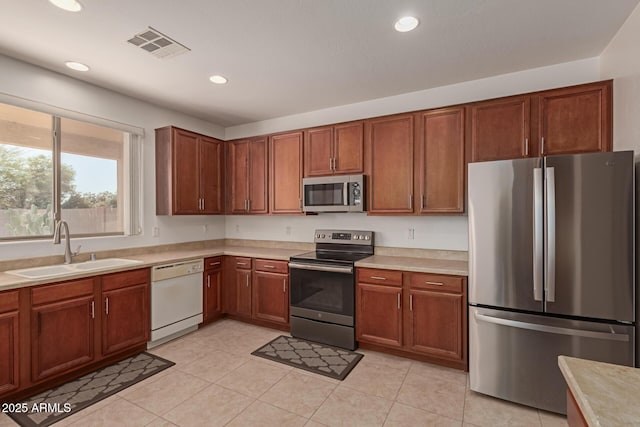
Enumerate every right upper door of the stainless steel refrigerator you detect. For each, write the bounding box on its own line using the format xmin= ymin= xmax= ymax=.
xmin=545 ymin=151 xmax=635 ymax=322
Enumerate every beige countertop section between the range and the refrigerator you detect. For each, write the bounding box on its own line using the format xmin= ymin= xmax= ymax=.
xmin=356 ymin=255 xmax=469 ymax=276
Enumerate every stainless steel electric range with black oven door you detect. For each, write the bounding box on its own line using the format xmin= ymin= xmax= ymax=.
xmin=289 ymin=230 xmax=373 ymax=350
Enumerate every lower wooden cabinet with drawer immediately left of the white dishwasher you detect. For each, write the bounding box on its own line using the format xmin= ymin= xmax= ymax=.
xmin=102 ymin=269 xmax=150 ymax=356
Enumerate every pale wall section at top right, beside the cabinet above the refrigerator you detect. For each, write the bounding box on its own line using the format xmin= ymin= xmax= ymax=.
xmin=600 ymin=5 xmax=640 ymax=156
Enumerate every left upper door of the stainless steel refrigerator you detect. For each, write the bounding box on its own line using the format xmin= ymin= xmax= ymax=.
xmin=468 ymin=159 xmax=543 ymax=311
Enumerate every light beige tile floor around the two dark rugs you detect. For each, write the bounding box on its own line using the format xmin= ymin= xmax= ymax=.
xmin=0 ymin=319 xmax=567 ymax=427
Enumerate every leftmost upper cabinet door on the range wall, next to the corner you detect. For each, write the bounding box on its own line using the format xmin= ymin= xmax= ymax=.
xmin=227 ymin=141 xmax=249 ymax=213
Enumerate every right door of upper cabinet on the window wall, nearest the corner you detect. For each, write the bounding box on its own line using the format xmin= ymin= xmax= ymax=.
xmin=199 ymin=137 xmax=224 ymax=214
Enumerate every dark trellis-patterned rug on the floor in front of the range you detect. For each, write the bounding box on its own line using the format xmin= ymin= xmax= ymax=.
xmin=251 ymin=335 xmax=364 ymax=381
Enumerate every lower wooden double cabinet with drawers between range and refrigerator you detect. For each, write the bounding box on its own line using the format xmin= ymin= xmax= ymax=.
xmin=356 ymin=268 xmax=467 ymax=370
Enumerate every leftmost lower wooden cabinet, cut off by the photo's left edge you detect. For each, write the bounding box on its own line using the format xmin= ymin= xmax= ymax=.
xmin=0 ymin=291 xmax=20 ymax=396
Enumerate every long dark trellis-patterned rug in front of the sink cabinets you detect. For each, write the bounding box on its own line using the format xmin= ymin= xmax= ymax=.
xmin=6 ymin=353 xmax=175 ymax=427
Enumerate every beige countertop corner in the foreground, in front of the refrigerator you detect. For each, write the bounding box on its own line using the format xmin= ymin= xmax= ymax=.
xmin=558 ymin=356 xmax=640 ymax=426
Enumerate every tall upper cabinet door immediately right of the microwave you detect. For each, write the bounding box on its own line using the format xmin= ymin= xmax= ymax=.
xmin=366 ymin=114 xmax=413 ymax=214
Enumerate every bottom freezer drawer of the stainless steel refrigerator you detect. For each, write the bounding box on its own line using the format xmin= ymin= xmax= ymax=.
xmin=469 ymin=307 xmax=635 ymax=413
